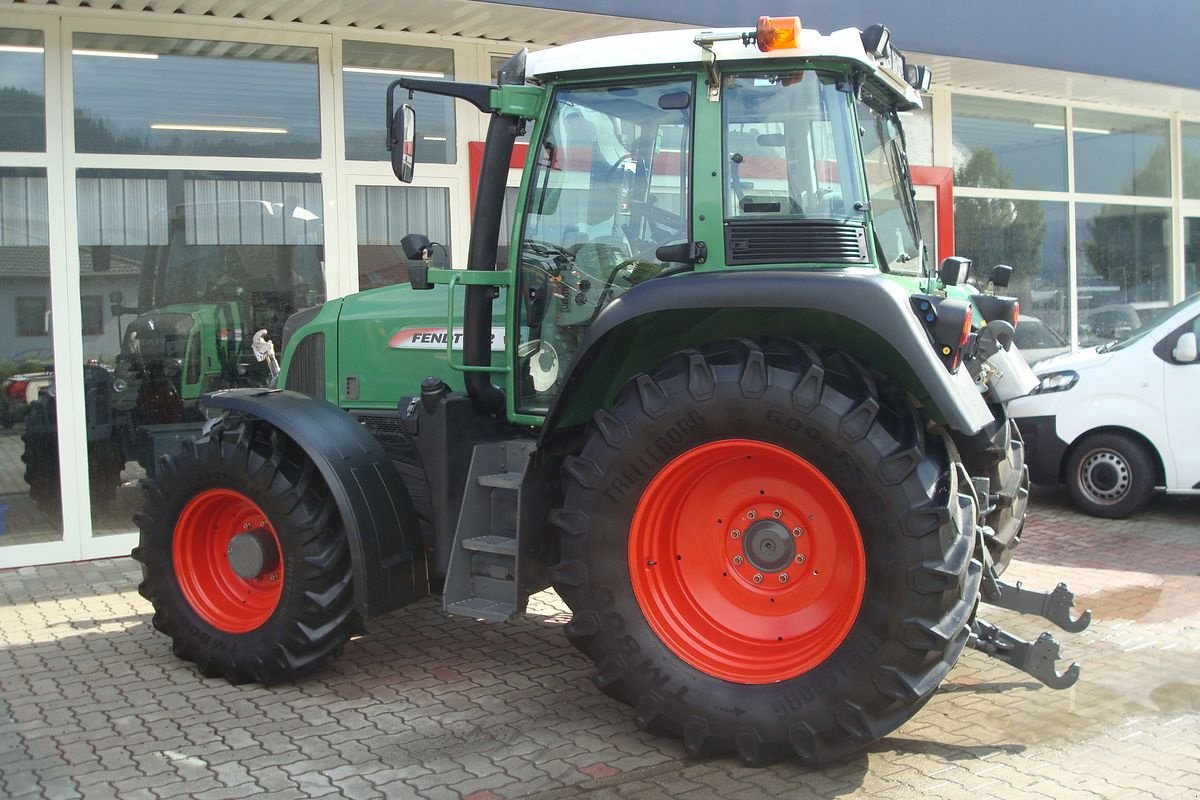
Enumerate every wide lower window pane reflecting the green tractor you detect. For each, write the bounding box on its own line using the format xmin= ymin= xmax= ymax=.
xmin=76 ymin=170 xmax=325 ymax=535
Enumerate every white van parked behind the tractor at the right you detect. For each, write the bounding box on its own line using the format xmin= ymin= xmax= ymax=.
xmin=1008 ymin=294 xmax=1200 ymax=517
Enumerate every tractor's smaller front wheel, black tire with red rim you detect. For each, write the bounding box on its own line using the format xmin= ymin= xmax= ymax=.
xmin=133 ymin=420 xmax=359 ymax=684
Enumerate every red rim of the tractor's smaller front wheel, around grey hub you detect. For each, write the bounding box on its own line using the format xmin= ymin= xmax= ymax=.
xmin=172 ymin=489 xmax=283 ymax=633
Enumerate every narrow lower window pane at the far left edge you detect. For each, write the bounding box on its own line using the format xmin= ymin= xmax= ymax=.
xmin=0 ymin=168 xmax=62 ymax=548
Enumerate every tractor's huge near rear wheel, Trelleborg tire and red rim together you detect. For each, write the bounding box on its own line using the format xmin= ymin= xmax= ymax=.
xmin=553 ymin=339 xmax=979 ymax=763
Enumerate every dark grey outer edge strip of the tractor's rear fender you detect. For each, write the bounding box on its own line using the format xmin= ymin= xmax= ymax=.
xmin=544 ymin=269 xmax=992 ymax=435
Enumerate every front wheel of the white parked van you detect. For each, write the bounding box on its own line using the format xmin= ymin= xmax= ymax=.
xmin=1067 ymin=433 xmax=1154 ymax=519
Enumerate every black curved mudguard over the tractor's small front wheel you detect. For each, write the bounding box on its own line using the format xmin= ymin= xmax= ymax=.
xmin=204 ymin=389 xmax=428 ymax=619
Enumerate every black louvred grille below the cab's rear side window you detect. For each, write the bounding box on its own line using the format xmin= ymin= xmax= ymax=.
xmin=725 ymin=219 xmax=869 ymax=264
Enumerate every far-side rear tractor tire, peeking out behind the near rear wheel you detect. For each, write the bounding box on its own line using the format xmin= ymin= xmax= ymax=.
xmin=961 ymin=417 xmax=1030 ymax=575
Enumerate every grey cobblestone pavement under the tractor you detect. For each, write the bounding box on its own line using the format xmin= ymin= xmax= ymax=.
xmin=0 ymin=484 xmax=1200 ymax=800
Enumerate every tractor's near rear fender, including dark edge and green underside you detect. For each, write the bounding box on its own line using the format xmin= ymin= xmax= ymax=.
xmin=542 ymin=270 xmax=992 ymax=441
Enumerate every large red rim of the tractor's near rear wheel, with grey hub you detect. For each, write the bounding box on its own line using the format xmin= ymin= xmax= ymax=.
xmin=629 ymin=439 xmax=866 ymax=684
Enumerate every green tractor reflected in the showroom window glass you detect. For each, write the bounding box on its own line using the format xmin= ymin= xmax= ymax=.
xmin=22 ymin=197 xmax=324 ymax=513
